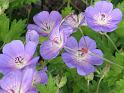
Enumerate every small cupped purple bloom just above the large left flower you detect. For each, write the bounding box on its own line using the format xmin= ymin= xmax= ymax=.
xmin=26 ymin=30 xmax=39 ymax=45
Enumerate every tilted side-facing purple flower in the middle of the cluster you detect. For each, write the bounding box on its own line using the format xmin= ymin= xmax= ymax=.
xmin=40 ymin=25 xmax=67 ymax=59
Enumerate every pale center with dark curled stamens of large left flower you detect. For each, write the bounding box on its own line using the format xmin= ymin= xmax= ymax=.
xmin=14 ymin=56 xmax=25 ymax=69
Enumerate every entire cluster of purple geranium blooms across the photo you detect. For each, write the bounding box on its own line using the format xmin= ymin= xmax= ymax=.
xmin=0 ymin=1 xmax=122 ymax=93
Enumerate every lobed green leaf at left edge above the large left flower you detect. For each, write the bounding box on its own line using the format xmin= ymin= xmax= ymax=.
xmin=0 ymin=15 xmax=26 ymax=43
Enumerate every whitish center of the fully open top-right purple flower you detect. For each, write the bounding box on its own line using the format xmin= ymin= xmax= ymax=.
xmin=94 ymin=13 xmax=111 ymax=26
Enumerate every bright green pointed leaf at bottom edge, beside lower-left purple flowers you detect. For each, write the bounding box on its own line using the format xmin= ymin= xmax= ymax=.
xmin=37 ymin=74 xmax=57 ymax=93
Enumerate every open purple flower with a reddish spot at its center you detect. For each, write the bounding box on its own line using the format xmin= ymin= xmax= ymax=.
xmin=62 ymin=36 xmax=103 ymax=75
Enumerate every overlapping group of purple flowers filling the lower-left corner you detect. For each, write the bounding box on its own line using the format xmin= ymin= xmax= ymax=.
xmin=0 ymin=40 xmax=47 ymax=93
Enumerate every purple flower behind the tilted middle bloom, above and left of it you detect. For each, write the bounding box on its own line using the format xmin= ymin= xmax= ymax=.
xmin=27 ymin=11 xmax=62 ymax=36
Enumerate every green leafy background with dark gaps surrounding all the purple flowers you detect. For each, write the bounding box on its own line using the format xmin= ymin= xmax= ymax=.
xmin=0 ymin=0 xmax=124 ymax=93
